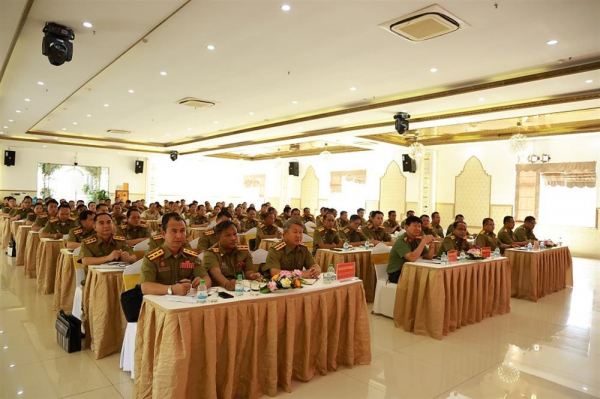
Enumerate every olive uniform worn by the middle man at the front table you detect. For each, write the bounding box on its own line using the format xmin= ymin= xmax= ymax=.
xmin=202 ymin=244 xmax=256 ymax=280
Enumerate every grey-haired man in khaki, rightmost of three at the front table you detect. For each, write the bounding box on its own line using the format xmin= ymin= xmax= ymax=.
xmin=265 ymin=219 xmax=321 ymax=278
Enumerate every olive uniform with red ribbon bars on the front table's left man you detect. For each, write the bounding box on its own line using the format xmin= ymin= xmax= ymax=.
xmin=140 ymin=244 xmax=208 ymax=285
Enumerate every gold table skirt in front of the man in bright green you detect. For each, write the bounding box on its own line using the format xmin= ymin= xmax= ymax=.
xmin=394 ymin=258 xmax=510 ymax=339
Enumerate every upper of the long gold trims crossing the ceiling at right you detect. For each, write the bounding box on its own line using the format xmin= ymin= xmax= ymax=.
xmin=166 ymin=61 xmax=600 ymax=147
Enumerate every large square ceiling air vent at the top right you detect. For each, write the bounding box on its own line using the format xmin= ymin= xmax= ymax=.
xmin=379 ymin=4 xmax=469 ymax=42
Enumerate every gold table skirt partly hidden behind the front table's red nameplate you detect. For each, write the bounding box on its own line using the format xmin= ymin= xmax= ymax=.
xmin=314 ymin=250 xmax=377 ymax=302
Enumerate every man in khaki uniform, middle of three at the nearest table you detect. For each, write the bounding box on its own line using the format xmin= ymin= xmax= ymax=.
xmin=203 ymin=220 xmax=262 ymax=291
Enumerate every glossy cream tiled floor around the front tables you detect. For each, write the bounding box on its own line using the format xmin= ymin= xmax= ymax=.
xmin=0 ymin=255 xmax=600 ymax=399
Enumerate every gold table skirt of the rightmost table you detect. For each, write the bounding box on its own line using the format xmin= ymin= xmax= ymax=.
xmin=505 ymin=247 xmax=573 ymax=302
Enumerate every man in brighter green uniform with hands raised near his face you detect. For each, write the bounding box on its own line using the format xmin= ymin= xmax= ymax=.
xmin=386 ymin=216 xmax=433 ymax=284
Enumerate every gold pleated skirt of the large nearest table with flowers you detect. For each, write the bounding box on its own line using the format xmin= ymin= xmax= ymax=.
xmin=133 ymin=282 xmax=371 ymax=399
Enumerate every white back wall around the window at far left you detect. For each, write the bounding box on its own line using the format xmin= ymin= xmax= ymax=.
xmin=0 ymin=146 xmax=146 ymax=197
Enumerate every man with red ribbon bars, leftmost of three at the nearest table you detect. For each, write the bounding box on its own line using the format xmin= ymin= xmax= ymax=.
xmin=140 ymin=213 xmax=212 ymax=295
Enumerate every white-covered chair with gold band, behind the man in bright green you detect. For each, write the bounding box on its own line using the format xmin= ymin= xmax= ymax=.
xmin=371 ymin=243 xmax=398 ymax=317
